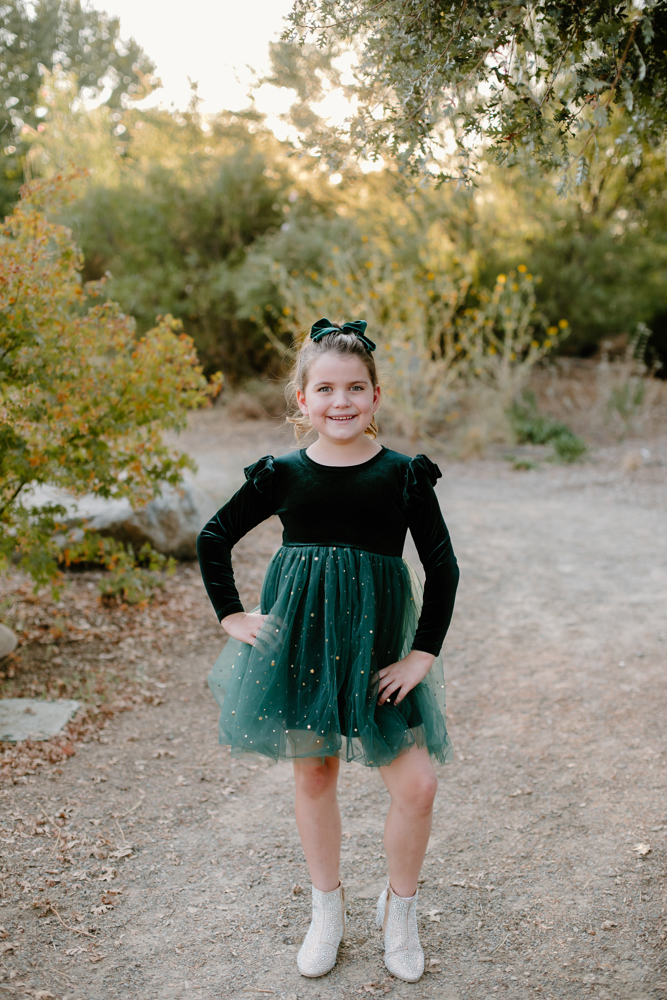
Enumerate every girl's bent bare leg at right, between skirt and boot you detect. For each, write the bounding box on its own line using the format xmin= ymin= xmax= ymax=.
xmin=380 ymin=747 xmax=438 ymax=896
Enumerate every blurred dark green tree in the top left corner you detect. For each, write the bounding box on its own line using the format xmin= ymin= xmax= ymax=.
xmin=0 ymin=0 xmax=158 ymax=216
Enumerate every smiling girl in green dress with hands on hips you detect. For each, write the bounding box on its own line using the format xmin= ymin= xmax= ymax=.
xmin=198 ymin=319 xmax=458 ymax=982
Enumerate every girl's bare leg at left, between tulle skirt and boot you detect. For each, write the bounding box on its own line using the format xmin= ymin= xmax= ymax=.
xmin=294 ymin=757 xmax=341 ymax=892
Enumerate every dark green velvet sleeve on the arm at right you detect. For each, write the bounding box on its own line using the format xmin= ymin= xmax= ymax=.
xmin=404 ymin=455 xmax=459 ymax=656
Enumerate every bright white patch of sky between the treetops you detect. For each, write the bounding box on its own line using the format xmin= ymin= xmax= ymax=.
xmin=100 ymin=0 xmax=293 ymax=120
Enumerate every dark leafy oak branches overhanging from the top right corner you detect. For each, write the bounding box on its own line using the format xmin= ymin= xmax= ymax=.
xmin=285 ymin=0 xmax=667 ymax=188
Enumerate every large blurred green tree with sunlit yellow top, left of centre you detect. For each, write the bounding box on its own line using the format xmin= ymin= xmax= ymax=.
xmin=31 ymin=92 xmax=333 ymax=381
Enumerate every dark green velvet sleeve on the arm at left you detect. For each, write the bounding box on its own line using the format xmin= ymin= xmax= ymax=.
xmin=197 ymin=455 xmax=276 ymax=621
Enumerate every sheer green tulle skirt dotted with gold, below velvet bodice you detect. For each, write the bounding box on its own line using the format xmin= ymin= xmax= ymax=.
xmin=208 ymin=545 xmax=451 ymax=767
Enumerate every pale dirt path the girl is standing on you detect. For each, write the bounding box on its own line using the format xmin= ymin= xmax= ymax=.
xmin=0 ymin=431 xmax=667 ymax=1000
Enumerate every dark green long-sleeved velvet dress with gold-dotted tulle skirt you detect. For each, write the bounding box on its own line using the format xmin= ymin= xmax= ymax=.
xmin=198 ymin=448 xmax=458 ymax=767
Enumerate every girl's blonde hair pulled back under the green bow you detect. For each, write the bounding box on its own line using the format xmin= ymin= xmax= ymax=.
xmin=285 ymin=323 xmax=379 ymax=441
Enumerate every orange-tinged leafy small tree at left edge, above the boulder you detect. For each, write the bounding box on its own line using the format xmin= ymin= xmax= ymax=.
xmin=0 ymin=176 xmax=220 ymax=582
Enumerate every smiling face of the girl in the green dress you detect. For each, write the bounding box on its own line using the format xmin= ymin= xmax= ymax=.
xmin=296 ymin=354 xmax=380 ymax=444
